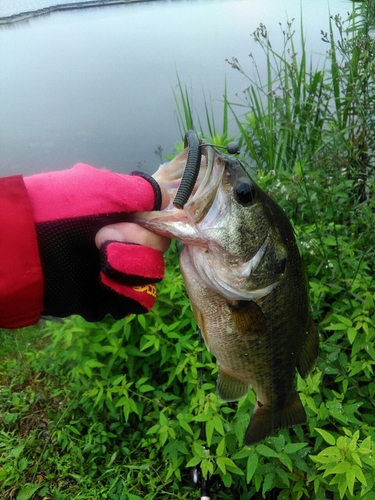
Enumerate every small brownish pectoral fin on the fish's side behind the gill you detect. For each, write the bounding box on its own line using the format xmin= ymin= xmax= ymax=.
xmin=227 ymin=300 xmax=267 ymax=337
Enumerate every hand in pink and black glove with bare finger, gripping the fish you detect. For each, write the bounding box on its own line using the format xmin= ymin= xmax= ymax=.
xmin=24 ymin=164 xmax=169 ymax=321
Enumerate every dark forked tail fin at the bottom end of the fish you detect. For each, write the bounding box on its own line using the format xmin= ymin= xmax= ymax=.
xmin=244 ymin=391 xmax=306 ymax=446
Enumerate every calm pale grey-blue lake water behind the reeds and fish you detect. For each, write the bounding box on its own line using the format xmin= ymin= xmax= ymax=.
xmin=0 ymin=0 xmax=351 ymax=175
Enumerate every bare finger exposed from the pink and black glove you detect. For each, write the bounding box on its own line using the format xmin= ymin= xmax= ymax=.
xmin=95 ymin=222 xmax=170 ymax=252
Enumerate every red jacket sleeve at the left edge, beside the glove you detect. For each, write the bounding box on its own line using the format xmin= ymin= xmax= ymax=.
xmin=0 ymin=175 xmax=43 ymax=328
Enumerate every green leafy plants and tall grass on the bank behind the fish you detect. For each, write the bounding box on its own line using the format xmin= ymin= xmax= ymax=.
xmin=0 ymin=0 xmax=375 ymax=500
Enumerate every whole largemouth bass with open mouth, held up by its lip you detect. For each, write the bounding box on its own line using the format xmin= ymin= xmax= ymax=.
xmin=134 ymin=144 xmax=319 ymax=446
